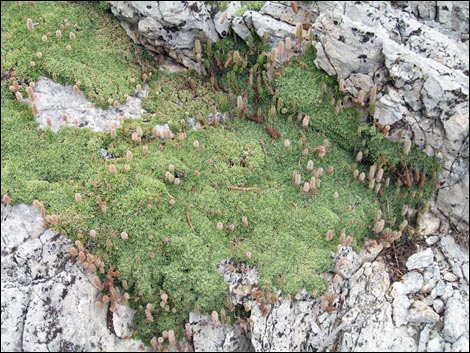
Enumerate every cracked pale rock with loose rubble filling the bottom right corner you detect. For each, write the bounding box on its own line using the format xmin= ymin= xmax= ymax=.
xmin=207 ymin=228 xmax=469 ymax=352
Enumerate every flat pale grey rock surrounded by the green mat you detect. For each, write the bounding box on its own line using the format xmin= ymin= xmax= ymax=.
xmin=30 ymin=77 xmax=142 ymax=132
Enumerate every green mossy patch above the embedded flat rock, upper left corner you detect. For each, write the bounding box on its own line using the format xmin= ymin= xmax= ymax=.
xmin=1 ymin=1 xmax=140 ymax=105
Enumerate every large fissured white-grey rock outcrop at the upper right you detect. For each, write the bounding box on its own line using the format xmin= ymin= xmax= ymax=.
xmin=313 ymin=2 xmax=469 ymax=231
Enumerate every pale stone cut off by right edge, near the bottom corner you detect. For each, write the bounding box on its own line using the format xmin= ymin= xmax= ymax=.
xmin=442 ymin=297 xmax=469 ymax=343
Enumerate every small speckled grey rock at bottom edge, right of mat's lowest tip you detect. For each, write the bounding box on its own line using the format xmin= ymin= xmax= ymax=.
xmin=189 ymin=312 xmax=254 ymax=352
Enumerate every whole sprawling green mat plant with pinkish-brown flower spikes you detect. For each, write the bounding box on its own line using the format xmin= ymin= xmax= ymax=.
xmin=1 ymin=2 xmax=437 ymax=346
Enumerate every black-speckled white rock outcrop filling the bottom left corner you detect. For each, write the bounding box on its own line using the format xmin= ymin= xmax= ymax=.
xmin=1 ymin=204 xmax=145 ymax=352
